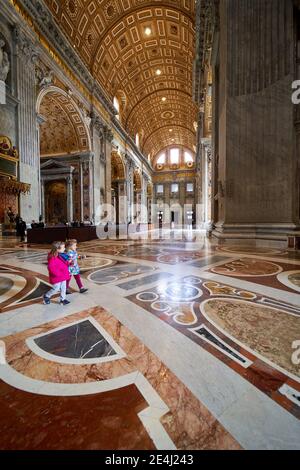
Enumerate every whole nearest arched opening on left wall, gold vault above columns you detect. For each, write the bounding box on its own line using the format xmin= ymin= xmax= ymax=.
xmin=37 ymin=86 xmax=93 ymax=224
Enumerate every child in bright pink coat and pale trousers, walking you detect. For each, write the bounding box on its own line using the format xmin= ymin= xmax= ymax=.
xmin=44 ymin=242 xmax=70 ymax=305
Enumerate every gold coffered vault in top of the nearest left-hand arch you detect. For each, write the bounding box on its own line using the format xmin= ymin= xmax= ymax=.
xmin=36 ymin=86 xmax=92 ymax=156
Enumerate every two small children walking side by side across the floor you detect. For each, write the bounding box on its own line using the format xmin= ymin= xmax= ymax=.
xmin=44 ymin=240 xmax=88 ymax=305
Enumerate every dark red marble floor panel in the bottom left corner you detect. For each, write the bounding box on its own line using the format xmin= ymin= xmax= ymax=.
xmin=0 ymin=381 xmax=155 ymax=450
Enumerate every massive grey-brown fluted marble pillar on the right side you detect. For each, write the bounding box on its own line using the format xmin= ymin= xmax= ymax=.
xmin=213 ymin=0 xmax=300 ymax=240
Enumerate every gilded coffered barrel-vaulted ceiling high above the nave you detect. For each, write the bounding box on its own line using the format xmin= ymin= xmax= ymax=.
xmin=45 ymin=0 xmax=197 ymax=162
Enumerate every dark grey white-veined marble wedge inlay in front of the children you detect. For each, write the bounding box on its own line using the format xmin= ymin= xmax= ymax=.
xmin=34 ymin=320 xmax=117 ymax=359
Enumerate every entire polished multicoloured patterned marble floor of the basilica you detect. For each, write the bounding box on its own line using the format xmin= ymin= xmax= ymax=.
xmin=0 ymin=233 xmax=300 ymax=450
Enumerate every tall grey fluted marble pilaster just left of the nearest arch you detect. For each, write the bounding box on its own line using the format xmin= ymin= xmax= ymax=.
xmin=14 ymin=27 xmax=41 ymax=222
